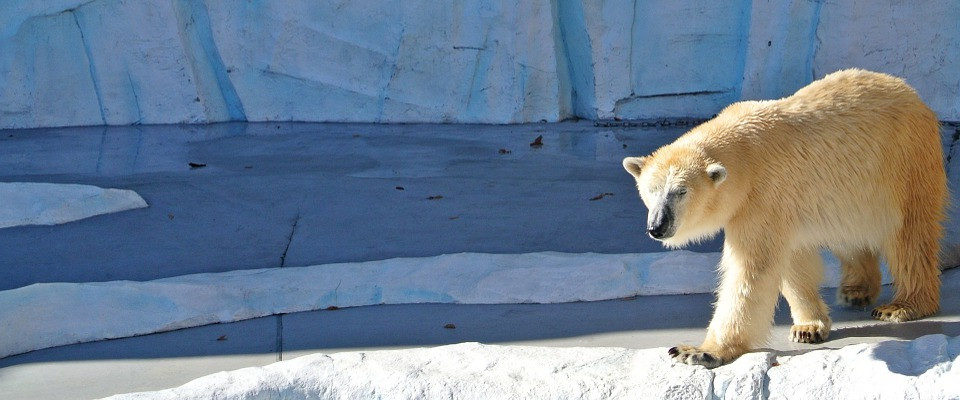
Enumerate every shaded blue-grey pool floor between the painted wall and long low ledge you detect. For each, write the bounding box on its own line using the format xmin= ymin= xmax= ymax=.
xmin=0 ymin=123 xmax=718 ymax=290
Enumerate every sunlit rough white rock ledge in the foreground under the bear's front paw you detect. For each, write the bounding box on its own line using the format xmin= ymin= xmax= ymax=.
xmin=105 ymin=335 xmax=960 ymax=399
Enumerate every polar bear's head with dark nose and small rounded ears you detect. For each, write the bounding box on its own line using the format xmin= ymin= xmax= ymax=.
xmin=623 ymin=145 xmax=727 ymax=248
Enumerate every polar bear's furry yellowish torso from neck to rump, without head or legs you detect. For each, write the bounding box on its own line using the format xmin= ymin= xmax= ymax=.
xmin=674 ymin=69 xmax=947 ymax=248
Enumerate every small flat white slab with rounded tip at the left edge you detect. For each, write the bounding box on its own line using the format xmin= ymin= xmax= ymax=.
xmin=0 ymin=182 xmax=147 ymax=228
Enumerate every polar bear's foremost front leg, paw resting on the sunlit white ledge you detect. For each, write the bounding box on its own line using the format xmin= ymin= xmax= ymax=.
xmin=669 ymin=238 xmax=787 ymax=368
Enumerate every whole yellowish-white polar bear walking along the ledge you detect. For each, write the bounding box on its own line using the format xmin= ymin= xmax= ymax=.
xmin=623 ymin=69 xmax=947 ymax=368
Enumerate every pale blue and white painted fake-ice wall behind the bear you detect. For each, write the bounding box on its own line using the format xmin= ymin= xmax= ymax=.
xmin=0 ymin=0 xmax=960 ymax=128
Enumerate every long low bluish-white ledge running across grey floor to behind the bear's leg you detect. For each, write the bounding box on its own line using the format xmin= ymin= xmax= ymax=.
xmin=0 ymin=250 xmax=892 ymax=357
